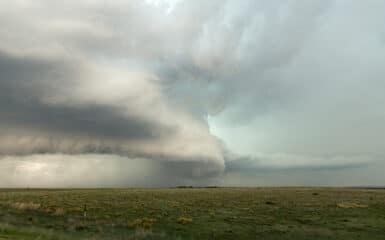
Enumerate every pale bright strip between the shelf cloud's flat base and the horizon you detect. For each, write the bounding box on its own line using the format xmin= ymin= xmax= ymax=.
xmin=0 ymin=154 xmax=222 ymax=188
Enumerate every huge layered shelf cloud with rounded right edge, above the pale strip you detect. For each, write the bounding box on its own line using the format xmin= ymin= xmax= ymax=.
xmin=0 ymin=43 xmax=223 ymax=176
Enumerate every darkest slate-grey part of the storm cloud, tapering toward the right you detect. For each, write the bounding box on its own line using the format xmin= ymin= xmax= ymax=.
xmin=0 ymin=52 xmax=173 ymax=143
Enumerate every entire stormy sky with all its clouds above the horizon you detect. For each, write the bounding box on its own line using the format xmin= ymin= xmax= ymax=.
xmin=0 ymin=0 xmax=385 ymax=187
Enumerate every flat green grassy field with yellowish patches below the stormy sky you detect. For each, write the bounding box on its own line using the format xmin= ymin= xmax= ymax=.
xmin=0 ymin=188 xmax=385 ymax=240
